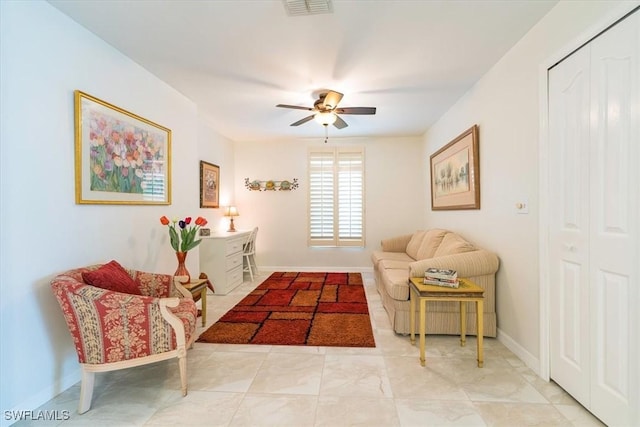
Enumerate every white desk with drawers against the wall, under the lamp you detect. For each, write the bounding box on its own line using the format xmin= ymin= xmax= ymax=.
xmin=199 ymin=230 xmax=251 ymax=295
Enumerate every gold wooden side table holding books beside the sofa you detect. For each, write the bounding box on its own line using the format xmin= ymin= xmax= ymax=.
xmin=409 ymin=277 xmax=484 ymax=368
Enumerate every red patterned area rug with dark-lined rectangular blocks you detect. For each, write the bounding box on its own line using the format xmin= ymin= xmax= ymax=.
xmin=198 ymin=273 xmax=376 ymax=347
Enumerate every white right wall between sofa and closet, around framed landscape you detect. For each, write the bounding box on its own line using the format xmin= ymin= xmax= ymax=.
xmin=424 ymin=1 xmax=636 ymax=369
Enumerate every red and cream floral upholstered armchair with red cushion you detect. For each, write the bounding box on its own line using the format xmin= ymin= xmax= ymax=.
xmin=51 ymin=261 xmax=197 ymax=414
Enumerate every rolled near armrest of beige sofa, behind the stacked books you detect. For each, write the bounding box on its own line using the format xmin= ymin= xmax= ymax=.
xmin=409 ymin=249 xmax=500 ymax=277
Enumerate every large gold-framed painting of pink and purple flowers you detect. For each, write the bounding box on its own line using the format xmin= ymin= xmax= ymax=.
xmin=74 ymin=90 xmax=171 ymax=205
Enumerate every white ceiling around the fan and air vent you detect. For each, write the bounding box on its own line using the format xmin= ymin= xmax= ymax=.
xmin=50 ymin=0 xmax=557 ymax=141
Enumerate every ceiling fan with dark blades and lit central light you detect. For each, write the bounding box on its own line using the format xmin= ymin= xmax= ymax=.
xmin=276 ymin=90 xmax=376 ymax=129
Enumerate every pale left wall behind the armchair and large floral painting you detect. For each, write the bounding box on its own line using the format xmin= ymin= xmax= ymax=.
xmin=0 ymin=1 xmax=215 ymax=425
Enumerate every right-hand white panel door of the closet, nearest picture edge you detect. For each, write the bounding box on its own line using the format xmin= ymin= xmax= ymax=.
xmin=589 ymin=13 xmax=640 ymax=425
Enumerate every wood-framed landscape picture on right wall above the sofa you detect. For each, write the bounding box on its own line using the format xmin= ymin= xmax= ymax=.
xmin=431 ymin=125 xmax=480 ymax=210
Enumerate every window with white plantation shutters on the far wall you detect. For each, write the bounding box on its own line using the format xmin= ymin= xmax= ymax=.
xmin=309 ymin=147 xmax=364 ymax=246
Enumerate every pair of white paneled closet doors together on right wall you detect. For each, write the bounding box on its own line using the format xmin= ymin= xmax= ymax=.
xmin=548 ymin=12 xmax=640 ymax=426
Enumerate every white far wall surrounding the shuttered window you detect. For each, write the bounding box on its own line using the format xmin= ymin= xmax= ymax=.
xmin=234 ymin=137 xmax=424 ymax=269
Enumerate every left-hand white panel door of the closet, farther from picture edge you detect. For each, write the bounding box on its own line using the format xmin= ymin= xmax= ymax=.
xmin=549 ymin=42 xmax=591 ymax=408
